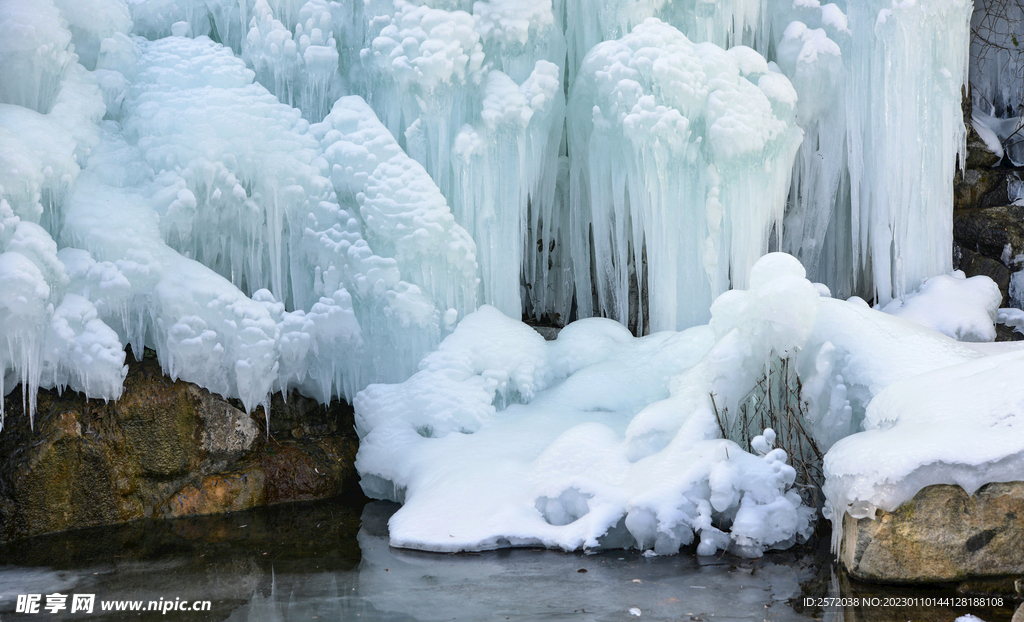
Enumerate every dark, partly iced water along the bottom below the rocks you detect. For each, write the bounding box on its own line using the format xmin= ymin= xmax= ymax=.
xmin=0 ymin=501 xmax=1012 ymax=622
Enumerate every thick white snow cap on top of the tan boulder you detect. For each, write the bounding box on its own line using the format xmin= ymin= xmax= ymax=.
xmin=824 ymin=350 xmax=1024 ymax=547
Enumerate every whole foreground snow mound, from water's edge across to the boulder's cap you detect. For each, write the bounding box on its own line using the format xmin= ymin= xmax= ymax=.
xmin=354 ymin=253 xmax=1024 ymax=555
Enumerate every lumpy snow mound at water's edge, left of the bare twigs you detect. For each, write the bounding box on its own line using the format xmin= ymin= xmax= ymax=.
xmin=354 ymin=256 xmax=818 ymax=556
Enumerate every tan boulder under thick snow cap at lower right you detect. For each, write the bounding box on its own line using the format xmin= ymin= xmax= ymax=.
xmin=840 ymin=482 xmax=1024 ymax=583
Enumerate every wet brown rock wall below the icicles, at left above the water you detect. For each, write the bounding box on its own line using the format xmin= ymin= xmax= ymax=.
xmin=0 ymin=357 xmax=358 ymax=540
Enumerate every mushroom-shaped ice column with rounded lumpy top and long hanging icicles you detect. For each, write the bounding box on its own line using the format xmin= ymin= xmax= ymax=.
xmin=567 ymin=18 xmax=802 ymax=331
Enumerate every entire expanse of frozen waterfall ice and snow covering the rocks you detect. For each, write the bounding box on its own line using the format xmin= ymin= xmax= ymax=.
xmin=0 ymin=0 xmax=1007 ymax=554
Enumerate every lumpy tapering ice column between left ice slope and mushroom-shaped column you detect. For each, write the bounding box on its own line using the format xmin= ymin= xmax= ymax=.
xmin=361 ymin=0 xmax=572 ymax=320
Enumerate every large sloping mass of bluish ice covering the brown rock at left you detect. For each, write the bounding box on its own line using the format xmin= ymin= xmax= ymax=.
xmin=0 ymin=1 xmax=477 ymax=420
